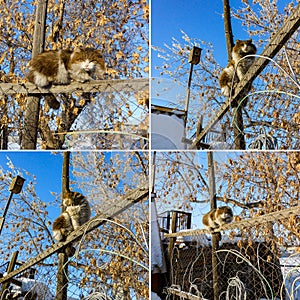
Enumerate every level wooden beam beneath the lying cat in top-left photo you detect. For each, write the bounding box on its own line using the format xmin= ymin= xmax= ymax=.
xmin=0 ymin=78 xmax=149 ymax=95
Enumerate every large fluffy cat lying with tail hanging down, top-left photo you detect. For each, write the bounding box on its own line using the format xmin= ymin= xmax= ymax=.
xmin=27 ymin=48 xmax=106 ymax=109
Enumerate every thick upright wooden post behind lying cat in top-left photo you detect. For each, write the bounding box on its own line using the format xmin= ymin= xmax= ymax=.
xmin=21 ymin=0 xmax=48 ymax=149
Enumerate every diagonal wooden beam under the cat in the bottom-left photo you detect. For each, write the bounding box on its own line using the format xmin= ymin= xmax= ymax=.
xmin=0 ymin=182 xmax=149 ymax=284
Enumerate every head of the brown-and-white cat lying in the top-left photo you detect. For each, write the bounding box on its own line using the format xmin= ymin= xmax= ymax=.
xmin=70 ymin=47 xmax=106 ymax=76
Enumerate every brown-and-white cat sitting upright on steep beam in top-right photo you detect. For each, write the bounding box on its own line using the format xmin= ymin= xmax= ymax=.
xmin=219 ymin=39 xmax=256 ymax=97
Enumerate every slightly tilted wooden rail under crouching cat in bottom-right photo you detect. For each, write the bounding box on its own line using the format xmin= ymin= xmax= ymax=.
xmin=165 ymin=206 xmax=300 ymax=238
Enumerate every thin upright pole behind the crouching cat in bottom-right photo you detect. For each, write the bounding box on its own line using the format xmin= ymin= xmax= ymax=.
xmin=207 ymin=151 xmax=221 ymax=300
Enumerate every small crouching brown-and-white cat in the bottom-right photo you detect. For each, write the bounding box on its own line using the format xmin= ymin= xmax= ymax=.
xmin=202 ymin=206 xmax=233 ymax=231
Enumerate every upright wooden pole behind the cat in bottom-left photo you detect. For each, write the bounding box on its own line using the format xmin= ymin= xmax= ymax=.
xmin=55 ymin=151 xmax=72 ymax=300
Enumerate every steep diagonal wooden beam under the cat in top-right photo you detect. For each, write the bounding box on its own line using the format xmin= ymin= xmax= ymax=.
xmin=190 ymin=4 xmax=300 ymax=149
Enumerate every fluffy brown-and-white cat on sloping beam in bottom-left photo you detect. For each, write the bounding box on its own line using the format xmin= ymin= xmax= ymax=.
xmin=52 ymin=191 xmax=91 ymax=242
